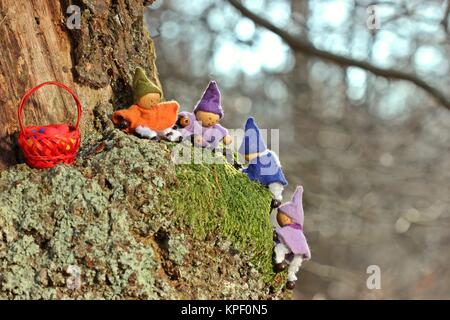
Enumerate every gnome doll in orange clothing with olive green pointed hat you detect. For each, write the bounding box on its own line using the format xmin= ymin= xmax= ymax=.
xmin=112 ymin=68 xmax=181 ymax=141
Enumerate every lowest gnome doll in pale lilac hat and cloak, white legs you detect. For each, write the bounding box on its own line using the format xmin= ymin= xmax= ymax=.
xmin=274 ymin=186 xmax=311 ymax=290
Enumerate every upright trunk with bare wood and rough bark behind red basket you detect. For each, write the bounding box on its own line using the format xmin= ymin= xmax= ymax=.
xmin=0 ymin=0 xmax=159 ymax=169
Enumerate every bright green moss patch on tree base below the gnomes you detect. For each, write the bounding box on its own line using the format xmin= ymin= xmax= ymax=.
xmin=171 ymin=149 xmax=274 ymax=281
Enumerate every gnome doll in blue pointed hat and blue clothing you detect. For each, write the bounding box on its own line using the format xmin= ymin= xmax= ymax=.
xmin=239 ymin=117 xmax=288 ymax=208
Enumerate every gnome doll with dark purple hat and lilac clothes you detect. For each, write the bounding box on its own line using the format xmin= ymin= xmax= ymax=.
xmin=178 ymin=81 xmax=231 ymax=149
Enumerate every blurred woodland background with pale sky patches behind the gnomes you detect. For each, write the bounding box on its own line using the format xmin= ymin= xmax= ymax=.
xmin=145 ymin=0 xmax=450 ymax=299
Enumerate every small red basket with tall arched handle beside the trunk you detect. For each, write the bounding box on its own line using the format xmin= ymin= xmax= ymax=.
xmin=18 ymin=82 xmax=82 ymax=169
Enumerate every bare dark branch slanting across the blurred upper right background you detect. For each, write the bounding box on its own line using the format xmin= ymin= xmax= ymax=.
xmin=228 ymin=0 xmax=450 ymax=110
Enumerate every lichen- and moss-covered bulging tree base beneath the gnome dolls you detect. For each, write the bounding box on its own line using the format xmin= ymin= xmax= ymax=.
xmin=0 ymin=105 xmax=283 ymax=299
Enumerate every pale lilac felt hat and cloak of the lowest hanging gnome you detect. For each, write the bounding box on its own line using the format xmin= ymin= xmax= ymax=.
xmin=276 ymin=186 xmax=311 ymax=260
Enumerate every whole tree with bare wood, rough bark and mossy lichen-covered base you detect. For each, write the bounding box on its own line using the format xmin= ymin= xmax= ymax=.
xmin=0 ymin=0 xmax=286 ymax=299
